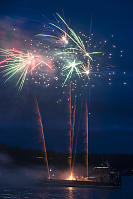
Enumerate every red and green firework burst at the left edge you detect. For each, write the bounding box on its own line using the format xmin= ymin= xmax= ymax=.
xmin=0 ymin=49 xmax=52 ymax=90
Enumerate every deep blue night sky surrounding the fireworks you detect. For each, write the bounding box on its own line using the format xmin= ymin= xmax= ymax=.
xmin=0 ymin=0 xmax=133 ymax=153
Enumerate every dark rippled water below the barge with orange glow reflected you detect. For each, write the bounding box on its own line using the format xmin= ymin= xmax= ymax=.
xmin=0 ymin=177 xmax=133 ymax=199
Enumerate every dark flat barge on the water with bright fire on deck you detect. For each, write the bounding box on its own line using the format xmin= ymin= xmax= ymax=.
xmin=39 ymin=166 xmax=121 ymax=188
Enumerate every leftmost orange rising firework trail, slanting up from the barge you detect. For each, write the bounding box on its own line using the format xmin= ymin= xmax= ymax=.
xmin=35 ymin=99 xmax=50 ymax=177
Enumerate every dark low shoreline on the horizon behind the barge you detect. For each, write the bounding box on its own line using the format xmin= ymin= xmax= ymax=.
xmin=0 ymin=144 xmax=133 ymax=175
